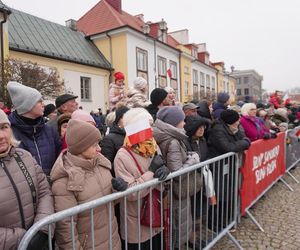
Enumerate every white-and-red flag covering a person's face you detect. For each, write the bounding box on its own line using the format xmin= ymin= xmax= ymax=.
xmin=125 ymin=120 xmax=153 ymax=145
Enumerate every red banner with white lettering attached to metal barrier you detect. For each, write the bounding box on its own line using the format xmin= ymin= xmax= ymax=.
xmin=240 ymin=133 xmax=286 ymax=215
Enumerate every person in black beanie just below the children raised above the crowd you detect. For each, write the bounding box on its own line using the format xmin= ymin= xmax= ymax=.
xmin=146 ymin=88 xmax=170 ymax=121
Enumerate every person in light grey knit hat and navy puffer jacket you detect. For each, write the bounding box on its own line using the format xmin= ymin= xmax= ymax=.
xmin=7 ymin=82 xmax=61 ymax=175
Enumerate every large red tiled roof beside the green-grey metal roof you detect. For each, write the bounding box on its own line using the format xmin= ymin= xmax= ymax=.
xmin=77 ymin=0 xmax=144 ymax=36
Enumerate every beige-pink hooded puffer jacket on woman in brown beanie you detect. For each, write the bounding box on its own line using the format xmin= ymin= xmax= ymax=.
xmin=51 ymin=151 xmax=121 ymax=250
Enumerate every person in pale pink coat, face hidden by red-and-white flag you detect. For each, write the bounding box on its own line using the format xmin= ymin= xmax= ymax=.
xmin=114 ymin=108 xmax=170 ymax=250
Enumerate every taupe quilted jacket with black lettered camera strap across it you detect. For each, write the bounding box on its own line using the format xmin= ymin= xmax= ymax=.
xmin=0 ymin=147 xmax=54 ymax=250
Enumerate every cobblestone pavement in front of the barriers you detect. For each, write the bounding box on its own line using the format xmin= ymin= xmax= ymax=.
xmin=213 ymin=165 xmax=300 ymax=250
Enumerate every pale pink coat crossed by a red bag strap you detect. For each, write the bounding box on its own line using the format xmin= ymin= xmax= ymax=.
xmin=114 ymin=148 xmax=160 ymax=244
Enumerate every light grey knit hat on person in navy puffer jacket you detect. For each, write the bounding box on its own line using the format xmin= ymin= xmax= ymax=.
xmin=7 ymin=82 xmax=42 ymax=115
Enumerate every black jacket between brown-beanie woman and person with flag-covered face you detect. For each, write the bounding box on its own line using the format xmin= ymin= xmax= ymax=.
xmin=100 ymin=123 xmax=126 ymax=166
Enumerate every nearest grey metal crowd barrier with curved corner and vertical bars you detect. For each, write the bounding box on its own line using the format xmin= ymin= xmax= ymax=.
xmin=18 ymin=153 xmax=242 ymax=250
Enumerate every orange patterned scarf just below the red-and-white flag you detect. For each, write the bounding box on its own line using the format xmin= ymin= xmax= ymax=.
xmin=124 ymin=136 xmax=157 ymax=158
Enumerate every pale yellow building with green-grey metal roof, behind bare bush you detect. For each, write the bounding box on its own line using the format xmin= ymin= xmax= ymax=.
xmin=4 ymin=3 xmax=111 ymax=111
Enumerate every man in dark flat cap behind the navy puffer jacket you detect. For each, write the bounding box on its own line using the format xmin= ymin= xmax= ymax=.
xmin=48 ymin=94 xmax=78 ymax=130
